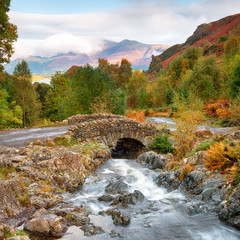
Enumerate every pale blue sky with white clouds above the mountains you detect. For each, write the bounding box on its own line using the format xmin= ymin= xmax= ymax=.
xmin=9 ymin=0 xmax=240 ymax=59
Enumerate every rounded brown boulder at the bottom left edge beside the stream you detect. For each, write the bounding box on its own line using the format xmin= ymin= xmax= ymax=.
xmin=24 ymin=214 xmax=67 ymax=237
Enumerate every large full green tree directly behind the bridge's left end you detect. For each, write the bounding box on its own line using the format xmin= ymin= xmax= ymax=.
xmin=64 ymin=66 xmax=115 ymax=116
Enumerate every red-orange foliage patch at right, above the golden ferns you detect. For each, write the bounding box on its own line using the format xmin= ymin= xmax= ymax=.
xmin=203 ymin=99 xmax=231 ymax=119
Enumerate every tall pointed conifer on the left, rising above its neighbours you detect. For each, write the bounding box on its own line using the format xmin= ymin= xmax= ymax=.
xmin=12 ymin=60 xmax=41 ymax=127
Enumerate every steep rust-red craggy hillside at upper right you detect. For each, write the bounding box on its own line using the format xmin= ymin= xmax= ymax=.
xmin=147 ymin=14 xmax=240 ymax=78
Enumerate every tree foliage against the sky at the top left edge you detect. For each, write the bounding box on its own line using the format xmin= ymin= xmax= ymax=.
xmin=0 ymin=0 xmax=18 ymax=71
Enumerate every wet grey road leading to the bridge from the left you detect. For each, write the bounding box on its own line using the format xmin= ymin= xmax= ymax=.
xmin=0 ymin=126 xmax=69 ymax=147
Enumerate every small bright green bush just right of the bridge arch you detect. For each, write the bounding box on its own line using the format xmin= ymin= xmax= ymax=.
xmin=151 ymin=134 xmax=174 ymax=153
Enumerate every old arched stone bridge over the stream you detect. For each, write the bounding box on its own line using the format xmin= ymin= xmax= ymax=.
xmin=68 ymin=114 xmax=163 ymax=158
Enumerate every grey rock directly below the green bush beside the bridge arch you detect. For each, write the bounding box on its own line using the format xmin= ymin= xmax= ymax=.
xmin=137 ymin=151 xmax=172 ymax=169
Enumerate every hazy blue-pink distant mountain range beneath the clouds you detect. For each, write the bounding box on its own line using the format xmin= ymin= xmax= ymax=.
xmin=4 ymin=40 xmax=169 ymax=75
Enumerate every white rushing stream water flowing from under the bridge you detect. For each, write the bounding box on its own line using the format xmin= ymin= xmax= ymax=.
xmin=63 ymin=159 xmax=240 ymax=240
